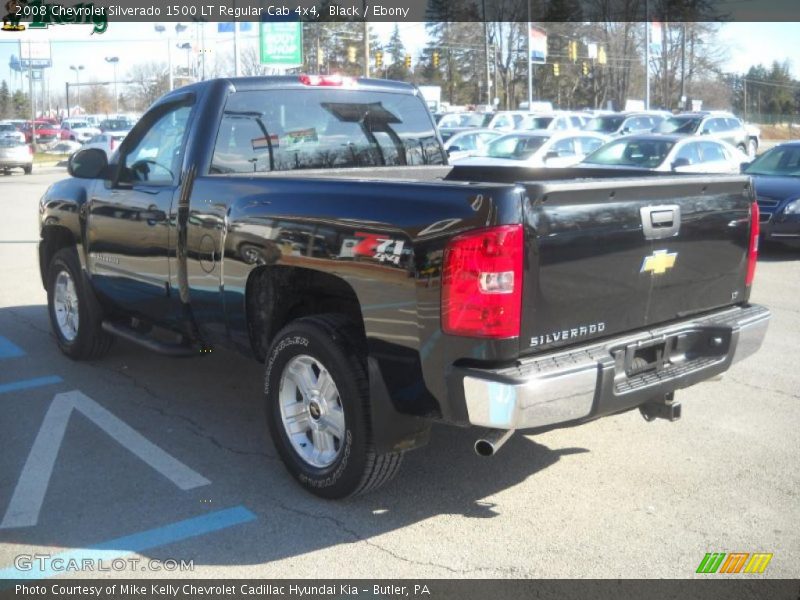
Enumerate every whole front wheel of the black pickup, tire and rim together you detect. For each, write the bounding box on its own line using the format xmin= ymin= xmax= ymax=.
xmin=47 ymin=247 xmax=114 ymax=360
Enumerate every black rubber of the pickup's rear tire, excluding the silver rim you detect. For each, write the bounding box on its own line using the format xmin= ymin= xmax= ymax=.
xmin=264 ymin=315 xmax=403 ymax=499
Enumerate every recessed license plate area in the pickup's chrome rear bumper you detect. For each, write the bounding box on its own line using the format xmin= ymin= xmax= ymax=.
xmin=612 ymin=327 xmax=732 ymax=381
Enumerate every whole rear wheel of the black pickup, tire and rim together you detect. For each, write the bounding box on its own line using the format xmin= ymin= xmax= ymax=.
xmin=264 ymin=315 xmax=403 ymax=499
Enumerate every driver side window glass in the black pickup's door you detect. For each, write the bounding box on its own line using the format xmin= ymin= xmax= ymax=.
xmin=122 ymin=105 xmax=192 ymax=185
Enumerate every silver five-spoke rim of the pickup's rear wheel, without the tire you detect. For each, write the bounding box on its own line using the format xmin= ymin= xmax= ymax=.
xmin=279 ymin=354 xmax=346 ymax=468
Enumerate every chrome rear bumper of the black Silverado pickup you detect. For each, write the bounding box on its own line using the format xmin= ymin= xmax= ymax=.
xmin=450 ymin=305 xmax=770 ymax=429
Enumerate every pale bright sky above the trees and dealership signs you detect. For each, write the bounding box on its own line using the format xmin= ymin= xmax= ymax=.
xmin=0 ymin=22 xmax=800 ymax=108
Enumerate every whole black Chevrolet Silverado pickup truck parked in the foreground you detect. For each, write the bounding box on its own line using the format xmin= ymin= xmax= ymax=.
xmin=39 ymin=76 xmax=769 ymax=498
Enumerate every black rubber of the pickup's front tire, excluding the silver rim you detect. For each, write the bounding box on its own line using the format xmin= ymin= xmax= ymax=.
xmin=47 ymin=247 xmax=114 ymax=360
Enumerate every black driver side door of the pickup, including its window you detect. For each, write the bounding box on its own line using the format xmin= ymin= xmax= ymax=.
xmin=86 ymin=96 xmax=193 ymax=322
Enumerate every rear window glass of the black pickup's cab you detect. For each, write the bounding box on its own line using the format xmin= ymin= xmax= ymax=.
xmin=210 ymin=88 xmax=445 ymax=174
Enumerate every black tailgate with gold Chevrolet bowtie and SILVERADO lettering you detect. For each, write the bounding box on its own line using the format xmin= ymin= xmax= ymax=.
xmin=520 ymin=176 xmax=753 ymax=354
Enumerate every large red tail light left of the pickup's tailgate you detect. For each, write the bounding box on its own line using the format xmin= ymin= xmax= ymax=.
xmin=441 ymin=225 xmax=524 ymax=339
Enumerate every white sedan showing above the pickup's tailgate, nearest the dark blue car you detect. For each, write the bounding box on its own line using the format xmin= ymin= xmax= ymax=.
xmin=580 ymin=134 xmax=749 ymax=173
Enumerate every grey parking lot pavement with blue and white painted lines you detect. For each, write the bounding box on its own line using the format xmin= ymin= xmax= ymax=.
xmin=0 ymin=169 xmax=800 ymax=578
